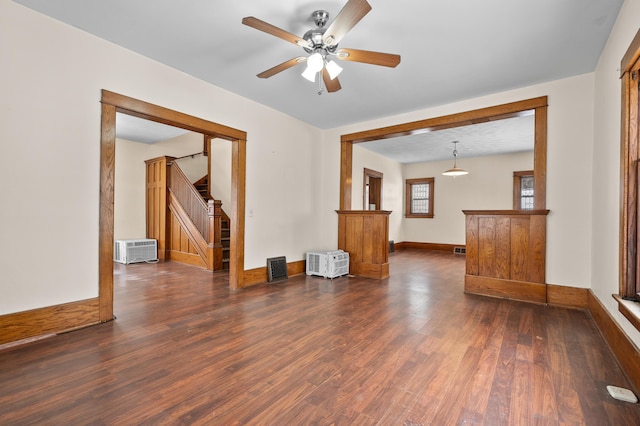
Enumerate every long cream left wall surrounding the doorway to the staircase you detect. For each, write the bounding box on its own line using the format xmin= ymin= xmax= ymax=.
xmin=0 ymin=0 xmax=325 ymax=314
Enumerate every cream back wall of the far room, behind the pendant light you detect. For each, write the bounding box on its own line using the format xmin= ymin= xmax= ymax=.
xmin=403 ymin=151 xmax=533 ymax=245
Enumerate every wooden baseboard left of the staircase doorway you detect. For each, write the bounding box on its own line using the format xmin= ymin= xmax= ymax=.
xmin=0 ymin=298 xmax=100 ymax=345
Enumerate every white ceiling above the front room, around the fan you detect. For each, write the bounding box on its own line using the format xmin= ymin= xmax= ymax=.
xmin=14 ymin=0 xmax=623 ymax=158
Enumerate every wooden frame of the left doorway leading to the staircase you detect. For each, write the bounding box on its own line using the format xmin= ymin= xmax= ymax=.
xmin=98 ymin=90 xmax=247 ymax=322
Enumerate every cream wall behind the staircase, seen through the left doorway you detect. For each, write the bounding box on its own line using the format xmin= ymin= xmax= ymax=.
xmin=113 ymin=131 xmax=205 ymax=240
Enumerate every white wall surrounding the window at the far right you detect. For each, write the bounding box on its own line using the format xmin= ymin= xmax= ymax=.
xmin=589 ymin=0 xmax=640 ymax=346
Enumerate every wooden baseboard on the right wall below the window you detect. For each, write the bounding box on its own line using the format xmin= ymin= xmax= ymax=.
xmin=587 ymin=290 xmax=640 ymax=390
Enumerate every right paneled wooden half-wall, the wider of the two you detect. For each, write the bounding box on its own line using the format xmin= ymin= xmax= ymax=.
xmin=464 ymin=210 xmax=549 ymax=303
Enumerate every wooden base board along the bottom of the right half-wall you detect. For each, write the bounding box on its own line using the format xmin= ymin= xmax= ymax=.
xmin=464 ymin=275 xmax=547 ymax=303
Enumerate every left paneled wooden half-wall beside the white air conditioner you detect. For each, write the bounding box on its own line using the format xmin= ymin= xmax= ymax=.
xmin=337 ymin=210 xmax=391 ymax=279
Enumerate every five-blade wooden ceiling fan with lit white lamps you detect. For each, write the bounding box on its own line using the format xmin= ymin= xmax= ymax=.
xmin=242 ymin=0 xmax=400 ymax=95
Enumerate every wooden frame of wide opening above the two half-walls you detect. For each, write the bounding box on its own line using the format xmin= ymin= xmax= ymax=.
xmin=340 ymin=96 xmax=547 ymax=210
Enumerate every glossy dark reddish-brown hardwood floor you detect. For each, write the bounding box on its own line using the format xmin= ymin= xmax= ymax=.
xmin=0 ymin=250 xmax=640 ymax=426
